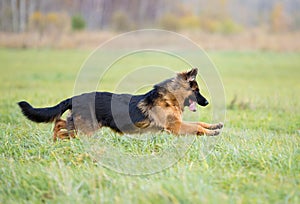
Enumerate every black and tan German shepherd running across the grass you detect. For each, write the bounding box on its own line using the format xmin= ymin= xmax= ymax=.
xmin=18 ymin=68 xmax=223 ymax=140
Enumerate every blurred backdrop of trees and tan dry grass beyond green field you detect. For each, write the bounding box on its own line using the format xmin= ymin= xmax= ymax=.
xmin=0 ymin=0 xmax=300 ymax=51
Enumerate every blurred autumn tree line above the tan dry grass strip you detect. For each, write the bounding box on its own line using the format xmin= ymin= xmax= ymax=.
xmin=0 ymin=0 xmax=300 ymax=34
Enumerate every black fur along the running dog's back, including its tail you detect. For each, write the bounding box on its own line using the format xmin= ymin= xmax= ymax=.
xmin=18 ymin=89 xmax=159 ymax=132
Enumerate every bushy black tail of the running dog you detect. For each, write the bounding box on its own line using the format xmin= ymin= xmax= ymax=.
xmin=18 ymin=98 xmax=72 ymax=123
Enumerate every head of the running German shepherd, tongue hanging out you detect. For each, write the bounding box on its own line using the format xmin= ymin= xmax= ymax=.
xmin=177 ymin=68 xmax=208 ymax=111
